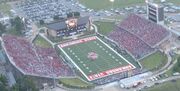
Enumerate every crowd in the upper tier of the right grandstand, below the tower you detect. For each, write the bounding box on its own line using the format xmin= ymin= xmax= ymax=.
xmin=119 ymin=14 xmax=169 ymax=47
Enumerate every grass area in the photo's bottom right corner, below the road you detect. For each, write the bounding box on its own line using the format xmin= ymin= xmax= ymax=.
xmin=144 ymin=79 xmax=180 ymax=91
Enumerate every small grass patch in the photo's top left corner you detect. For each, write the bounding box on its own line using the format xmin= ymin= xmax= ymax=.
xmin=0 ymin=3 xmax=11 ymax=15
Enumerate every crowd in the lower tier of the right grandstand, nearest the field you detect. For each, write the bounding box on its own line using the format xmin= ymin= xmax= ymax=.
xmin=109 ymin=27 xmax=154 ymax=59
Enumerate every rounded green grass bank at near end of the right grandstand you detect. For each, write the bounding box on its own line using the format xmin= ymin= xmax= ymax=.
xmin=140 ymin=51 xmax=167 ymax=70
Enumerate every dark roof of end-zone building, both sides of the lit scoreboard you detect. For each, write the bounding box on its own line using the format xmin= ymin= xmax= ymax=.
xmin=47 ymin=16 xmax=89 ymax=30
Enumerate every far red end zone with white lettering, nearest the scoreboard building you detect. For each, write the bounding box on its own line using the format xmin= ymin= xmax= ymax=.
xmin=59 ymin=36 xmax=96 ymax=48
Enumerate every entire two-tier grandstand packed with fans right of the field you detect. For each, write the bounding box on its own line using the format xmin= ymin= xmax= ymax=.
xmin=108 ymin=14 xmax=170 ymax=59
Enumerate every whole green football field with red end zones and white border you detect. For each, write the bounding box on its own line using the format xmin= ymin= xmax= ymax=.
xmin=58 ymin=36 xmax=136 ymax=81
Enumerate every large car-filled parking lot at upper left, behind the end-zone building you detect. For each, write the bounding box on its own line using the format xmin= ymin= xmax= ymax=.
xmin=15 ymin=0 xmax=89 ymax=21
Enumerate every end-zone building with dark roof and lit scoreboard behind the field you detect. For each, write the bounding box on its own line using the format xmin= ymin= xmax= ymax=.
xmin=46 ymin=16 xmax=91 ymax=37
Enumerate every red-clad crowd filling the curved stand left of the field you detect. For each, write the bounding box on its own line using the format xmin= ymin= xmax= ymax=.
xmin=2 ymin=35 xmax=74 ymax=78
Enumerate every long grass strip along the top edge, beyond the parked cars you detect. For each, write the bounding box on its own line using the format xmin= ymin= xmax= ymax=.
xmin=79 ymin=0 xmax=145 ymax=10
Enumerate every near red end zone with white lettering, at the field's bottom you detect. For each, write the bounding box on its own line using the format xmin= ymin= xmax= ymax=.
xmin=88 ymin=65 xmax=134 ymax=81
